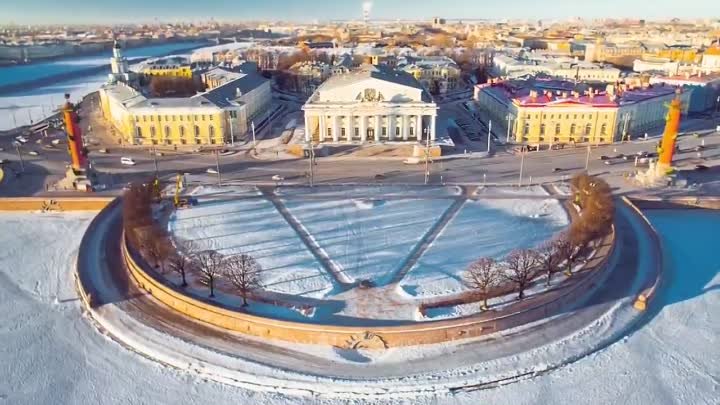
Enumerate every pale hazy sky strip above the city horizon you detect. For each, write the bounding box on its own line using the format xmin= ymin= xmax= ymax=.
xmin=0 ymin=0 xmax=720 ymax=24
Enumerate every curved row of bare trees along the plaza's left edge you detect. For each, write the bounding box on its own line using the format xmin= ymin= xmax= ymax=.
xmin=123 ymin=184 xmax=262 ymax=306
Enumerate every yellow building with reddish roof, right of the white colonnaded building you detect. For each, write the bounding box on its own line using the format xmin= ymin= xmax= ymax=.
xmin=475 ymin=79 xmax=688 ymax=146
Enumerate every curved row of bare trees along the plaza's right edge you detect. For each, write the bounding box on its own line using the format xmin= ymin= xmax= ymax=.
xmin=463 ymin=174 xmax=615 ymax=310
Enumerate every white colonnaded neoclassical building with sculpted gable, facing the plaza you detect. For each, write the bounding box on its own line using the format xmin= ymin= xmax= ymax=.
xmin=303 ymin=65 xmax=437 ymax=143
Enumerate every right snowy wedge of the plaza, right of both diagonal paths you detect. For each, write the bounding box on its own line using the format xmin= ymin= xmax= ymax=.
xmin=400 ymin=198 xmax=568 ymax=298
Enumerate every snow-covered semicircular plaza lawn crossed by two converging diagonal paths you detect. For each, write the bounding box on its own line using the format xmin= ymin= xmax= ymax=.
xmin=169 ymin=186 xmax=568 ymax=321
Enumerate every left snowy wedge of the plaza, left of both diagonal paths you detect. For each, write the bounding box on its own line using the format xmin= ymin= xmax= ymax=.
xmin=169 ymin=188 xmax=333 ymax=298
